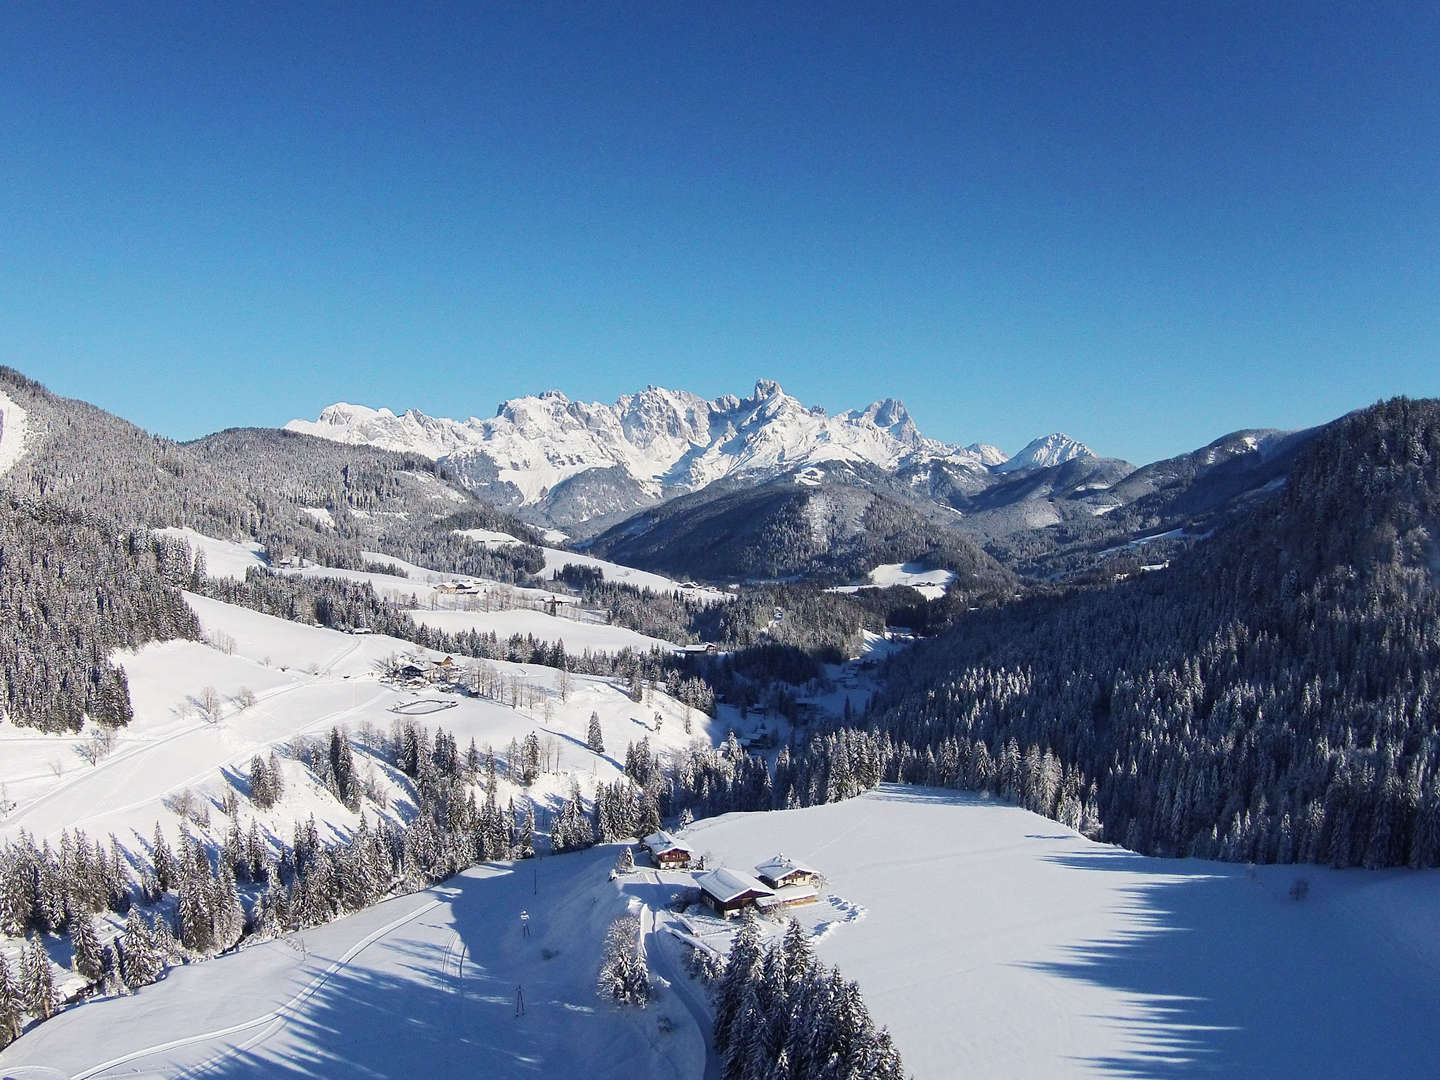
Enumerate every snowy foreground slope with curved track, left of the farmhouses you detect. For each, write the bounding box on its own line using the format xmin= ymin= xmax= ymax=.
xmin=0 ymin=848 xmax=706 ymax=1080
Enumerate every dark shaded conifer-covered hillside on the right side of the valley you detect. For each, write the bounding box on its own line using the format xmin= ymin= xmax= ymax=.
xmin=873 ymin=399 xmax=1440 ymax=867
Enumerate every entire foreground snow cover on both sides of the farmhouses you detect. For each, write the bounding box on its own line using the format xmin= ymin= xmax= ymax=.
xmin=0 ymin=788 xmax=1440 ymax=1080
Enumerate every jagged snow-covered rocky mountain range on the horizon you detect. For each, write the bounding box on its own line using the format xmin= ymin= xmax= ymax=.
xmin=285 ymin=380 xmax=1093 ymax=524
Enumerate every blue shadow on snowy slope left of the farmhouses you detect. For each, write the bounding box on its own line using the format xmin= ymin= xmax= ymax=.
xmin=184 ymin=848 xmax=668 ymax=1080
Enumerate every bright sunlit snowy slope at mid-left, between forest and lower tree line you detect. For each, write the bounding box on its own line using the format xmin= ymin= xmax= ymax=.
xmin=0 ymin=593 xmax=710 ymax=847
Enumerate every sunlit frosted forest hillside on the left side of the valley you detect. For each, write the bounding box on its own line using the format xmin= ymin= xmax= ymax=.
xmin=0 ymin=367 xmax=543 ymax=730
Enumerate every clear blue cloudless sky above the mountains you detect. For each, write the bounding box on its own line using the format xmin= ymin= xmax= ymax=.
xmin=0 ymin=0 xmax=1440 ymax=461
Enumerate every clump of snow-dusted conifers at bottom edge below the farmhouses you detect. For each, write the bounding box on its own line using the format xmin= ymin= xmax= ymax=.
xmin=714 ymin=912 xmax=904 ymax=1080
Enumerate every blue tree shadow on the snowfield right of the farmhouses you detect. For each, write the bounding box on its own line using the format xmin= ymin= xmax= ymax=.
xmin=1028 ymin=848 xmax=1440 ymax=1080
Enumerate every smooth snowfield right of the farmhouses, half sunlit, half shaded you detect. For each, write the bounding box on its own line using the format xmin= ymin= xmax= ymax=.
xmin=685 ymin=786 xmax=1440 ymax=1080
